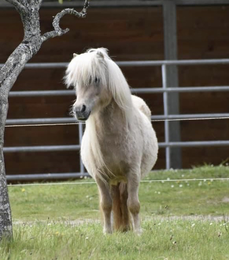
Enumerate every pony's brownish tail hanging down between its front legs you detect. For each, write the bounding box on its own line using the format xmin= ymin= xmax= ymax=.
xmin=111 ymin=182 xmax=131 ymax=232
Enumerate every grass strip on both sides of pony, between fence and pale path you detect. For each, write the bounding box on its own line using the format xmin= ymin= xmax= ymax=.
xmin=9 ymin=166 xmax=229 ymax=221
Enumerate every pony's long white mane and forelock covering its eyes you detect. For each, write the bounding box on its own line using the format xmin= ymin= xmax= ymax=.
xmin=65 ymin=48 xmax=132 ymax=120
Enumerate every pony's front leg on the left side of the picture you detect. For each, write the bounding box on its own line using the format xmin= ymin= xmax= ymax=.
xmin=96 ymin=180 xmax=112 ymax=234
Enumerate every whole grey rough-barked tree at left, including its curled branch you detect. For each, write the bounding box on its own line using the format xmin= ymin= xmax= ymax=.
xmin=0 ymin=0 xmax=89 ymax=240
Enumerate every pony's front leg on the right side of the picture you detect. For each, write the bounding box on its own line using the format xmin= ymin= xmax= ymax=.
xmin=127 ymin=174 xmax=142 ymax=234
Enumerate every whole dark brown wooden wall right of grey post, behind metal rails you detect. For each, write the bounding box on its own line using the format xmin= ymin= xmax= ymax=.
xmin=177 ymin=6 xmax=229 ymax=167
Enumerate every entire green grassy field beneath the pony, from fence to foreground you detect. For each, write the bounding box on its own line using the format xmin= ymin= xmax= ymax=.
xmin=0 ymin=166 xmax=229 ymax=260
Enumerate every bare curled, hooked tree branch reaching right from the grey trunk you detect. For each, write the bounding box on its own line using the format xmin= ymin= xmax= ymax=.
xmin=41 ymin=0 xmax=89 ymax=42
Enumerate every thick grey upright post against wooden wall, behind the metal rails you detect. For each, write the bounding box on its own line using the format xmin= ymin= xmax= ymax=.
xmin=163 ymin=0 xmax=182 ymax=169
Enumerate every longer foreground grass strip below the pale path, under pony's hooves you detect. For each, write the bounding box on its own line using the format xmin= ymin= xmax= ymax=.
xmin=0 ymin=219 xmax=229 ymax=260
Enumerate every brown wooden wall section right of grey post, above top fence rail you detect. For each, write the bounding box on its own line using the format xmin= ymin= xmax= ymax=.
xmin=177 ymin=6 xmax=229 ymax=59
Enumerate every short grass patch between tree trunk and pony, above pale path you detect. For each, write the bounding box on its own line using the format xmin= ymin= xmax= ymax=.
xmin=9 ymin=182 xmax=99 ymax=221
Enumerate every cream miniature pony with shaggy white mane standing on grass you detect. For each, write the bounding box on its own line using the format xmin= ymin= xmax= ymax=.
xmin=65 ymin=48 xmax=158 ymax=233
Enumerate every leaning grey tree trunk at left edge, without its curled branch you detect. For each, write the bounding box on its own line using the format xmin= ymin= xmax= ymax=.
xmin=0 ymin=2 xmax=41 ymax=239
